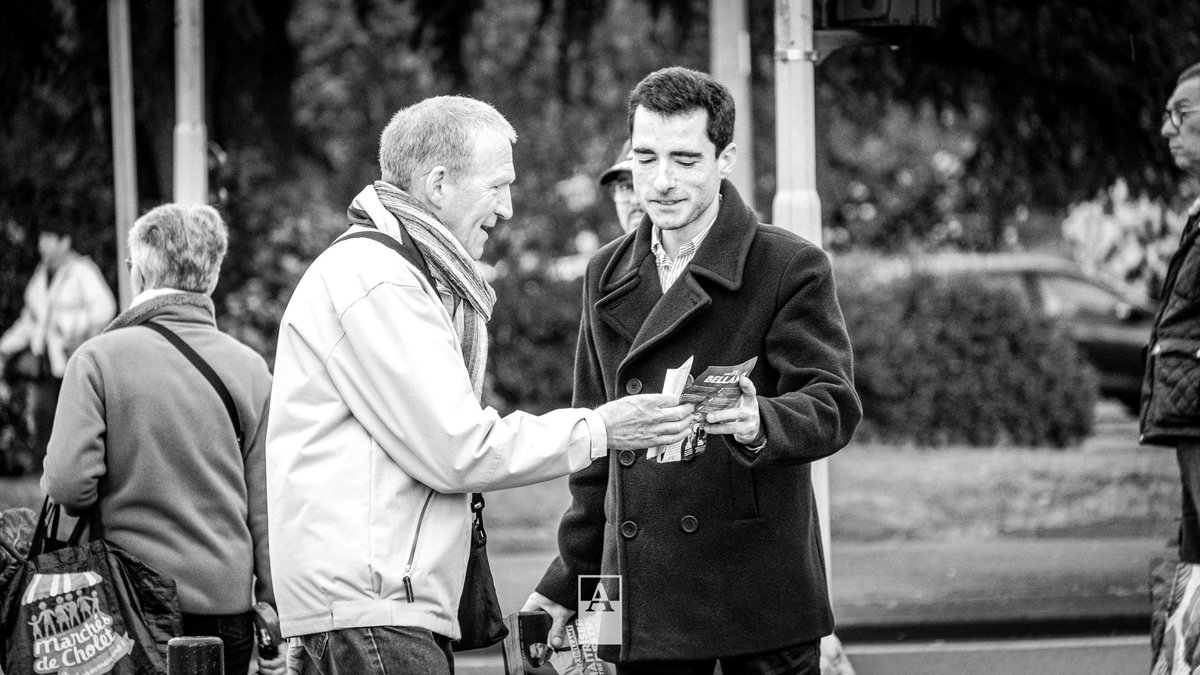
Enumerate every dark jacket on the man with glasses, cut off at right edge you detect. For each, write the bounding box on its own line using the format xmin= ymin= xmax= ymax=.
xmin=1141 ymin=210 xmax=1200 ymax=446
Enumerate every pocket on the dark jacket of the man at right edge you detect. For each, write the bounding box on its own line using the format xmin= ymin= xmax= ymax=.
xmin=1148 ymin=338 xmax=1200 ymax=426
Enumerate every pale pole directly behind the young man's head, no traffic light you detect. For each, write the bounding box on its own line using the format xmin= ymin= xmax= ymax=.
xmin=708 ymin=0 xmax=755 ymax=209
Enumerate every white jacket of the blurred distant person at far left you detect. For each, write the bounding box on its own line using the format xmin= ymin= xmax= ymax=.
xmin=0 ymin=255 xmax=116 ymax=377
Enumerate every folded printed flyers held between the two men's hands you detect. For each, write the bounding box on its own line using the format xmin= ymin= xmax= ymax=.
xmin=646 ymin=357 xmax=758 ymax=464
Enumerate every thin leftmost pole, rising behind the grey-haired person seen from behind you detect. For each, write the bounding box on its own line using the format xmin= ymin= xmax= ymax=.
xmin=108 ymin=0 xmax=138 ymax=309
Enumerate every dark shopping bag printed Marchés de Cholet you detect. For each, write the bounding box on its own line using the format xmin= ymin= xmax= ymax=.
xmin=0 ymin=497 xmax=182 ymax=675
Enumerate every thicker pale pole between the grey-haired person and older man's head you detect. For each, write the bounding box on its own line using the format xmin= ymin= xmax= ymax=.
xmin=174 ymin=0 xmax=209 ymax=204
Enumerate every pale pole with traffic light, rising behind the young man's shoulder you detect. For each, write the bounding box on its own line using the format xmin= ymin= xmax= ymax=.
xmin=772 ymin=0 xmax=833 ymax=571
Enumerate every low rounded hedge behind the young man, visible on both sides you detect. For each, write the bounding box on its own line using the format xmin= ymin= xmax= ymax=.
xmin=490 ymin=256 xmax=1098 ymax=447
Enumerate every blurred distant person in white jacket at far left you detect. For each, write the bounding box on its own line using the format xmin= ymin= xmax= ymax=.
xmin=0 ymin=223 xmax=116 ymax=466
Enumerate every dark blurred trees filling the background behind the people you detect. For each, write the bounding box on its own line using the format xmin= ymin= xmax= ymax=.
xmin=0 ymin=0 xmax=1200 ymax=451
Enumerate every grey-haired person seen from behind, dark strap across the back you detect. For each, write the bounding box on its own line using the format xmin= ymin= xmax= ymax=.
xmin=31 ymin=204 xmax=283 ymax=674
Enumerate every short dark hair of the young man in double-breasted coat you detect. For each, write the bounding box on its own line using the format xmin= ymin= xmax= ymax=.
xmin=629 ymin=66 xmax=734 ymax=155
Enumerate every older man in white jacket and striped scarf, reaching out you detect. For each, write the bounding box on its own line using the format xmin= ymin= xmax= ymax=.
xmin=266 ymin=96 xmax=691 ymax=675
